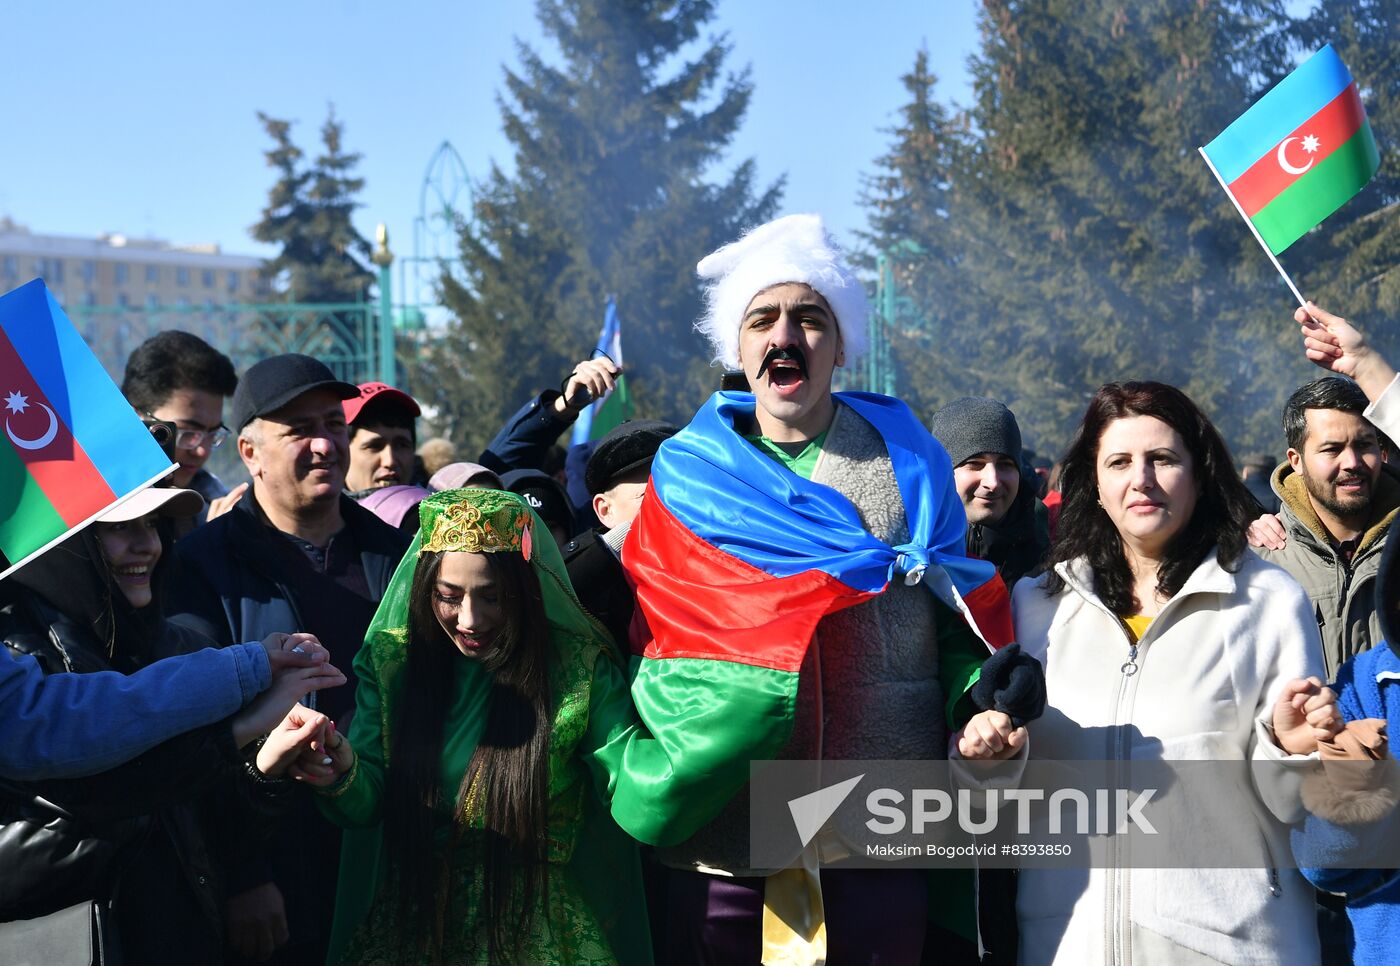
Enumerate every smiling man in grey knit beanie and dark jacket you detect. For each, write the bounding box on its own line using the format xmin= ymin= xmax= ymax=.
xmin=931 ymin=396 xmax=1050 ymax=589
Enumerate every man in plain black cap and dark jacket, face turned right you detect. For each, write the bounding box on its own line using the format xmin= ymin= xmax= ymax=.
xmin=169 ymin=354 xmax=409 ymax=963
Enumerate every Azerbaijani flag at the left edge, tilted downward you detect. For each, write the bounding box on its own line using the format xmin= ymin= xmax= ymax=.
xmin=0 ymin=279 xmax=174 ymax=577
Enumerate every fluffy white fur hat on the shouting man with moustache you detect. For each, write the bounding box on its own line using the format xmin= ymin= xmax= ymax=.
xmin=696 ymin=214 xmax=869 ymax=370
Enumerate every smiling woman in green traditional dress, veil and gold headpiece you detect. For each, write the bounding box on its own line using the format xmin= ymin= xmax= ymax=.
xmin=269 ymin=490 xmax=651 ymax=963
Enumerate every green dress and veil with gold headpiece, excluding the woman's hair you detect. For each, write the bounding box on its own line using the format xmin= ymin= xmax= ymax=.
xmin=318 ymin=490 xmax=651 ymax=966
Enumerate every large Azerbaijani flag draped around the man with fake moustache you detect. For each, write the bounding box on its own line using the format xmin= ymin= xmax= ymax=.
xmin=613 ymin=392 xmax=1014 ymax=844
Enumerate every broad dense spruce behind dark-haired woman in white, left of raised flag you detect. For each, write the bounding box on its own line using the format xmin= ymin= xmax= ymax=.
xmin=856 ymin=0 xmax=1316 ymax=452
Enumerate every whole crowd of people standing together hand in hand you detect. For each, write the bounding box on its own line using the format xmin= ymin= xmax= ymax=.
xmin=0 ymin=216 xmax=1400 ymax=966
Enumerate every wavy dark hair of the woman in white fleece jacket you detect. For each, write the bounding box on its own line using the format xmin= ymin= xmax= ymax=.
xmin=1046 ymin=382 xmax=1254 ymax=615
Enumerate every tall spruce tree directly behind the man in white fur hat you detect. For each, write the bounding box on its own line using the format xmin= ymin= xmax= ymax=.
xmin=426 ymin=0 xmax=781 ymax=447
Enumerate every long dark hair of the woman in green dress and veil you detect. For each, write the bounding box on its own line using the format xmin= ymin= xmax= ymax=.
xmin=384 ymin=553 xmax=553 ymax=962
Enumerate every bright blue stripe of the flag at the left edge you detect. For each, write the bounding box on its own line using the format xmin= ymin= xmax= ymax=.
xmin=0 ymin=279 xmax=171 ymax=496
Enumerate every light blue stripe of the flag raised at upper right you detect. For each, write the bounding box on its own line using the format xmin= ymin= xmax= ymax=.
xmin=1203 ymin=43 xmax=1351 ymax=185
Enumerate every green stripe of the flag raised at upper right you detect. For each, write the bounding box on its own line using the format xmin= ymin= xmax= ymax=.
xmin=1250 ymin=123 xmax=1380 ymax=255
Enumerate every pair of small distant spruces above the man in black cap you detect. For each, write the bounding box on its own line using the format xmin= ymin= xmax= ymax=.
xmin=252 ymin=108 xmax=375 ymax=302
